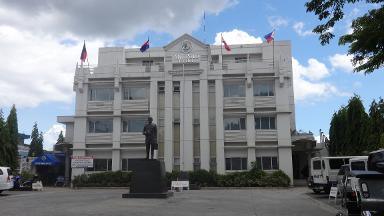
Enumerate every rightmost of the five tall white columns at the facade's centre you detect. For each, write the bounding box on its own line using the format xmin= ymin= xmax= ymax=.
xmin=215 ymin=79 xmax=225 ymax=174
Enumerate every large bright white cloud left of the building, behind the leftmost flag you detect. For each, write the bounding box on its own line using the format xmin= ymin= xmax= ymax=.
xmin=0 ymin=25 xmax=102 ymax=107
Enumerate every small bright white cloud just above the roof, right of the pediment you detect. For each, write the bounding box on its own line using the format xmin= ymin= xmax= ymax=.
xmin=214 ymin=29 xmax=263 ymax=45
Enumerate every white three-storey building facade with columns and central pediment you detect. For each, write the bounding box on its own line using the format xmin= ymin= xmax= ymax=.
xmin=58 ymin=34 xmax=296 ymax=179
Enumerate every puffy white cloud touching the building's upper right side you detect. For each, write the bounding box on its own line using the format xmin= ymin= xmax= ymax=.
xmin=292 ymin=58 xmax=350 ymax=101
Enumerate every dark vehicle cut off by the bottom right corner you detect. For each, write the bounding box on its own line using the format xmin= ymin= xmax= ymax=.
xmin=345 ymin=150 xmax=384 ymax=216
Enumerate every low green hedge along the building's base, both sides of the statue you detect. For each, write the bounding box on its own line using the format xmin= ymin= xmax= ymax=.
xmin=72 ymin=168 xmax=291 ymax=187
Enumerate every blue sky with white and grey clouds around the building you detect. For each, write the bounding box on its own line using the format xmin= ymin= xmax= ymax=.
xmin=0 ymin=0 xmax=384 ymax=150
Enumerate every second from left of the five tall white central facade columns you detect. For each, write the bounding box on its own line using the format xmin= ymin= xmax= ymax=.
xmin=164 ymin=80 xmax=173 ymax=172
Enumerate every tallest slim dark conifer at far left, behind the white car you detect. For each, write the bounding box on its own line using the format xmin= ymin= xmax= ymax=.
xmin=7 ymin=105 xmax=19 ymax=169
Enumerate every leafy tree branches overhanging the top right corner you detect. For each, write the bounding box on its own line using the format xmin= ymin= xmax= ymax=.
xmin=305 ymin=0 xmax=384 ymax=74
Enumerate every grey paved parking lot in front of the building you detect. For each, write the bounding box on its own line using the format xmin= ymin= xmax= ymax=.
xmin=0 ymin=187 xmax=337 ymax=216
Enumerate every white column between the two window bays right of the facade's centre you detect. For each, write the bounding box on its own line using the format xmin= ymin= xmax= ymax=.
xmin=245 ymin=74 xmax=256 ymax=169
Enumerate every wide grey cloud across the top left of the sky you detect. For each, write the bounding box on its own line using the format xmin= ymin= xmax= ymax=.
xmin=0 ymin=0 xmax=237 ymax=38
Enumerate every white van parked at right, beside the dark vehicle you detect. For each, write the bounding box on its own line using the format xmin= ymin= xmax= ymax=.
xmin=308 ymin=156 xmax=353 ymax=193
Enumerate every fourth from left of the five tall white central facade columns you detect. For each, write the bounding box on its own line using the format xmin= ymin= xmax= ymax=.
xmin=200 ymin=79 xmax=210 ymax=170
